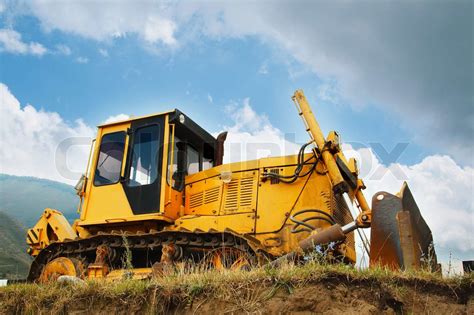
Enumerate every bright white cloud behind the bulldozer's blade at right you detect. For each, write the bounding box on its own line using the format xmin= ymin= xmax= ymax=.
xmin=344 ymin=145 xmax=474 ymax=259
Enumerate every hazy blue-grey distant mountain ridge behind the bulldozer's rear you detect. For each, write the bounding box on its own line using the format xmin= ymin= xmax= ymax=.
xmin=0 ymin=174 xmax=79 ymax=227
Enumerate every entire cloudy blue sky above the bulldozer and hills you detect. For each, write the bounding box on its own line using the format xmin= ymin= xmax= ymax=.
xmin=0 ymin=0 xmax=474 ymax=270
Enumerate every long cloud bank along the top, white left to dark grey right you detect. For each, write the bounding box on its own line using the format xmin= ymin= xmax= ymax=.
xmin=10 ymin=0 xmax=474 ymax=164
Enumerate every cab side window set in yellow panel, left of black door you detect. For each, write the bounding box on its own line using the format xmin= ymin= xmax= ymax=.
xmin=94 ymin=131 xmax=126 ymax=186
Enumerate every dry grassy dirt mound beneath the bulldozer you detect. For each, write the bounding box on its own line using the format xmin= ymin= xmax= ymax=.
xmin=0 ymin=266 xmax=474 ymax=314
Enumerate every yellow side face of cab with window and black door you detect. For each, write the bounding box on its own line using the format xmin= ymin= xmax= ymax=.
xmin=81 ymin=116 xmax=166 ymax=225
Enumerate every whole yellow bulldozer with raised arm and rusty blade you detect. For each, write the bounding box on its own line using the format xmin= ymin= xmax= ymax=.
xmin=26 ymin=90 xmax=436 ymax=282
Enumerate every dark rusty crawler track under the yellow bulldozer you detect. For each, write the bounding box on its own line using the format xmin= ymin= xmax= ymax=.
xmin=28 ymin=231 xmax=257 ymax=282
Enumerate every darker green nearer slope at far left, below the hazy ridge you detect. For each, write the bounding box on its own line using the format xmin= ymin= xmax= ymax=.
xmin=0 ymin=211 xmax=31 ymax=279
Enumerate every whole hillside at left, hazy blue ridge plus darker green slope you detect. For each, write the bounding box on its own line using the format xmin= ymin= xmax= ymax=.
xmin=0 ymin=174 xmax=79 ymax=279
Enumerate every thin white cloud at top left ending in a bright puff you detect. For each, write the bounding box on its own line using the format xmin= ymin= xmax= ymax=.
xmin=24 ymin=1 xmax=177 ymax=46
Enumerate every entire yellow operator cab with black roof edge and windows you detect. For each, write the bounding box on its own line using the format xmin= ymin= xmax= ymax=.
xmin=78 ymin=109 xmax=225 ymax=227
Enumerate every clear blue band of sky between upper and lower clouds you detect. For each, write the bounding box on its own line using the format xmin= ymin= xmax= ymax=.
xmin=0 ymin=8 xmax=433 ymax=164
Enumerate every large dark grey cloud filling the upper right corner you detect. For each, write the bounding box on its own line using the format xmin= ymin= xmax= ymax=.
xmin=191 ymin=1 xmax=474 ymax=164
